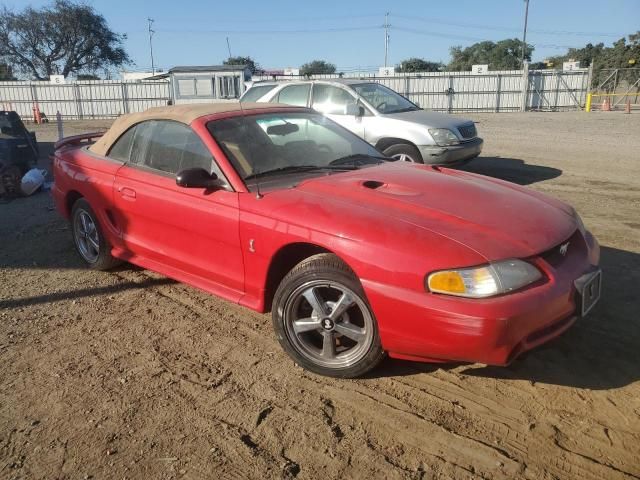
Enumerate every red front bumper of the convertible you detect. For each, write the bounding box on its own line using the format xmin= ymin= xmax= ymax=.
xmin=363 ymin=233 xmax=600 ymax=365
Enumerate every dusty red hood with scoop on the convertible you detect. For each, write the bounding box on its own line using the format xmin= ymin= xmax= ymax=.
xmin=297 ymin=163 xmax=577 ymax=261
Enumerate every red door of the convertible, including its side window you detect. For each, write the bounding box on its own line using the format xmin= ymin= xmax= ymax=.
xmin=109 ymin=120 xmax=244 ymax=292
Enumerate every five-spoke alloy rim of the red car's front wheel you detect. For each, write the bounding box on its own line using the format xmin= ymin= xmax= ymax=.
xmin=284 ymin=280 xmax=374 ymax=368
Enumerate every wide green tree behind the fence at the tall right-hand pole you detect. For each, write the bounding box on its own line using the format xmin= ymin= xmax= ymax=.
xmin=448 ymin=38 xmax=533 ymax=72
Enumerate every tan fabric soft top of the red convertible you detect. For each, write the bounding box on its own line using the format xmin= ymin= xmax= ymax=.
xmin=89 ymin=102 xmax=291 ymax=156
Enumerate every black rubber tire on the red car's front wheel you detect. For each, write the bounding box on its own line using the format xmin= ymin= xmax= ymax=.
xmin=271 ymin=253 xmax=385 ymax=378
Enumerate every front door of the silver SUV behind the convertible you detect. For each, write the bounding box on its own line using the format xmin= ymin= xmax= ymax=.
xmin=311 ymin=83 xmax=367 ymax=138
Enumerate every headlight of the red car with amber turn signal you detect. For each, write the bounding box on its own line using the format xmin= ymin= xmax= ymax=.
xmin=427 ymin=259 xmax=542 ymax=298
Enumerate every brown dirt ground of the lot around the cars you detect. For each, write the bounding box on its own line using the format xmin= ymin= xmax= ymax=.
xmin=0 ymin=112 xmax=640 ymax=480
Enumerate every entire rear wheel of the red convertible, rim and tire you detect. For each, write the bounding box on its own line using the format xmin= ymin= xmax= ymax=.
xmin=71 ymin=198 xmax=121 ymax=270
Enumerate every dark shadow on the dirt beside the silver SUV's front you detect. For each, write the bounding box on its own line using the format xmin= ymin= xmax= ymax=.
xmin=460 ymin=157 xmax=562 ymax=185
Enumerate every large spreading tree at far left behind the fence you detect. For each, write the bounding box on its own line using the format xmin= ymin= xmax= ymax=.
xmin=0 ymin=0 xmax=131 ymax=80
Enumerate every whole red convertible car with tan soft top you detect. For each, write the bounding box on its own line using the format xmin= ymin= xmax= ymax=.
xmin=53 ymin=103 xmax=601 ymax=377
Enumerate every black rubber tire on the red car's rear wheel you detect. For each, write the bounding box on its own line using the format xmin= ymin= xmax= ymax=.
xmin=71 ymin=198 xmax=122 ymax=270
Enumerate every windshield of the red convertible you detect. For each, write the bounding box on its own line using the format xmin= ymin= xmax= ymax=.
xmin=207 ymin=112 xmax=386 ymax=189
